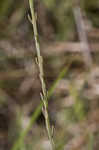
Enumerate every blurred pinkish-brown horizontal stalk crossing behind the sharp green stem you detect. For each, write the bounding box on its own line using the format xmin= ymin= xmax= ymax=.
xmin=0 ymin=40 xmax=99 ymax=60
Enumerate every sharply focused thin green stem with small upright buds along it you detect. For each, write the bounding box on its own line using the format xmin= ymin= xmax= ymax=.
xmin=29 ymin=0 xmax=54 ymax=149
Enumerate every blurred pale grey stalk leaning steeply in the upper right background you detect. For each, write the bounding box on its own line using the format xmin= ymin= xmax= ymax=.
xmin=73 ymin=6 xmax=92 ymax=68
